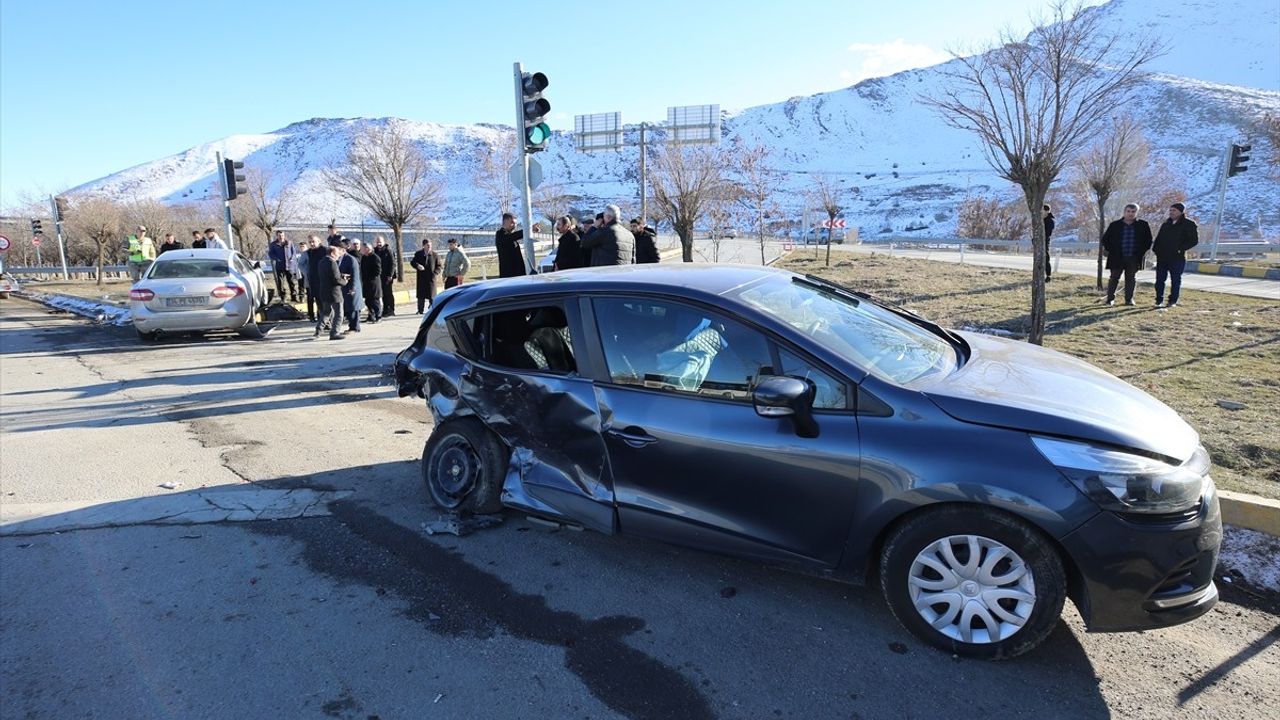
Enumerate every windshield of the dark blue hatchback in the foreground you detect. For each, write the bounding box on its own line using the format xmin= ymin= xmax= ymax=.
xmin=737 ymin=277 xmax=956 ymax=384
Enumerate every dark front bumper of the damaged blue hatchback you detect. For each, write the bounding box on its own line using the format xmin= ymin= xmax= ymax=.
xmin=1062 ymin=480 xmax=1222 ymax=633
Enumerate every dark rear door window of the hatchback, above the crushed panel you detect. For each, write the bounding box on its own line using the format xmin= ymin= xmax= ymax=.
xmin=450 ymin=304 xmax=577 ymax=373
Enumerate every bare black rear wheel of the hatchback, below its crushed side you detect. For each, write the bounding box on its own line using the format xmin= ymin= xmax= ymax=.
xmin=422 ymin=418 xmax=511 ymax=515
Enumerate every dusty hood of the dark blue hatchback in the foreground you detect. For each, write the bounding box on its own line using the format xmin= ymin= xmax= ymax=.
xmin=923 ymin=332 xmax=1199 ymax=461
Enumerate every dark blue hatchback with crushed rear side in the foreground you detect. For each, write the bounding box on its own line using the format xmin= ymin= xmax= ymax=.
xmin=396 ymin=264 xmax=1221 ymax=657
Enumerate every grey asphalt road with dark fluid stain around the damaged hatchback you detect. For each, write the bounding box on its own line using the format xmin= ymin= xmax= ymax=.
xmin=0 ymin=301 xmax=1280 ymax=719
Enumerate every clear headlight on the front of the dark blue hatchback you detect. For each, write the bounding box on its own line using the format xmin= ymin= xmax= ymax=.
xmin=1032 ymin=437 xmax=1208 ymax=514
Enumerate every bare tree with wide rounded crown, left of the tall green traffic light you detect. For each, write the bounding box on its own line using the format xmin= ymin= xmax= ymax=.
xmin=324 ymin=119 xmax=444 ymax=281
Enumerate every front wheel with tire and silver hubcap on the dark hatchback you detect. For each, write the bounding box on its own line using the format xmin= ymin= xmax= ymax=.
xmin=879 ymin=506 xmax=1066 ymax=660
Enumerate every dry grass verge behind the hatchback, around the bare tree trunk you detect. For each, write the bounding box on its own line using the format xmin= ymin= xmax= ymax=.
xmin=780 ymin=254 xmax=1280 ymax=498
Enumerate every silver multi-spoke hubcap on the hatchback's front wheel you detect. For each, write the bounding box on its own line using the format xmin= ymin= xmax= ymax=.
xmin=908 ymin=536 xmax=1036 ymax=644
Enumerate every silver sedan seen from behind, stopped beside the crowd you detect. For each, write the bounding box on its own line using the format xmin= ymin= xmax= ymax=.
xmin=129 ymin=249 xmax=266 ymax=340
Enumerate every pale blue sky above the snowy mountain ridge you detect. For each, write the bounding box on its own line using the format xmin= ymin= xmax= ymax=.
xmin=0 ymin=0 xmax=1096 ymax=208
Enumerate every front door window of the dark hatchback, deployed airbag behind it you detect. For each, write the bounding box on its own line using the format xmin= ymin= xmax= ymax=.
xmin=591 ymin=299 xmax=773 ymax=401
